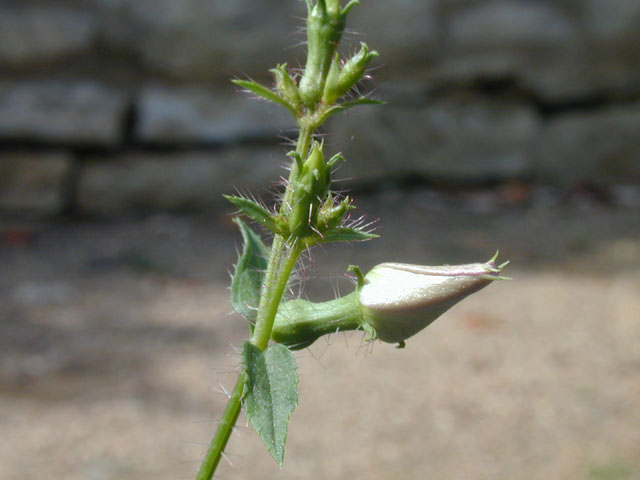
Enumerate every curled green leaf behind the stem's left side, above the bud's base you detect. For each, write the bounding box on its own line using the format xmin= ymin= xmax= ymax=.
xmin=231 ymin=217 xmax=269 ymax=331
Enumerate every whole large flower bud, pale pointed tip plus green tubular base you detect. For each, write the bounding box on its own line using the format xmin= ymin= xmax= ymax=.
xmin=271 ymin=252 xmax=509 ymax=350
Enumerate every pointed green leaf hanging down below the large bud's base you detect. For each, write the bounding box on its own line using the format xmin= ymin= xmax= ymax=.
xmin=242 ymin=342 xmax=298 ymax=466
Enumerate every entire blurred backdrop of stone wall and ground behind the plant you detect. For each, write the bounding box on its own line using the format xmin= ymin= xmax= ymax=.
xmin=0 ymin=0 xmax=640 ymax=480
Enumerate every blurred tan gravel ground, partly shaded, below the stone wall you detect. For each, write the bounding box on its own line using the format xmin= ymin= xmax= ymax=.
xmin=0 ymin=190 xmax=640 ymax=480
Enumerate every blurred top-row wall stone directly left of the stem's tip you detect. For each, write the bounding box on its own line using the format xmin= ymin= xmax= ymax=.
xmin=87 ymin=0 xmax=305 ymax=79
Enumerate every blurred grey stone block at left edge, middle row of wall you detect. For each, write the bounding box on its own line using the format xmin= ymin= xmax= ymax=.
xmin=0 ymin=81 xmax=127 ymax=146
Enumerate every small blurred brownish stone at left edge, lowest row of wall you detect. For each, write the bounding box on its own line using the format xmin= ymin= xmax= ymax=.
xmin=0 ymin=152 xmax=72 ymax=214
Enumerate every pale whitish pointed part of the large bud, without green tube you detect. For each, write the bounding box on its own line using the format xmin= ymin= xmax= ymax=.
xmin=360 ymin=253 xmax=508 ymax=344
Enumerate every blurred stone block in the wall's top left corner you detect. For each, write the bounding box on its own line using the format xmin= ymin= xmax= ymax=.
xmin=0 ymin=6 xmax=98 ymax=66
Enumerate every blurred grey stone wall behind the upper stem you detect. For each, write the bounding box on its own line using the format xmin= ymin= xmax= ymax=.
xmin=0 ymin=0 xmax=640 ymax=216
